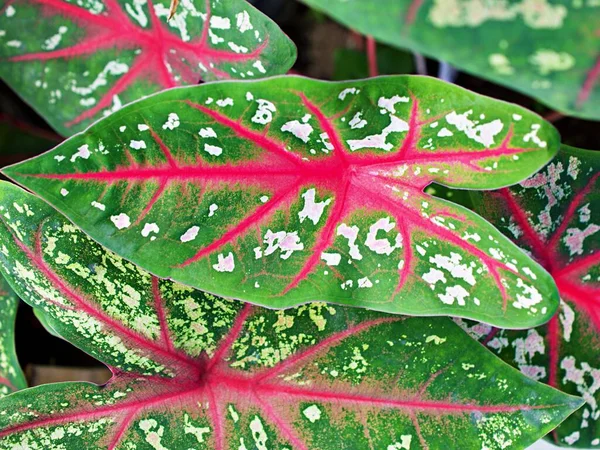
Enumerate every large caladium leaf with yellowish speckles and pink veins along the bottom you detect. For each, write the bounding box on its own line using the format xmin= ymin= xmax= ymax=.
xmin=0 ymin=183 xmax=582 ymax=450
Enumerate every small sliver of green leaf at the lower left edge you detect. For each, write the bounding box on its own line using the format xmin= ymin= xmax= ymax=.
xmin=0 ymin=276 xmax=27 ymax=397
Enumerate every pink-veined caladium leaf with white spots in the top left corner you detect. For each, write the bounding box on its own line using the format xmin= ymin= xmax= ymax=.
xmin=0 ymin=0 xmax=296 ymax=136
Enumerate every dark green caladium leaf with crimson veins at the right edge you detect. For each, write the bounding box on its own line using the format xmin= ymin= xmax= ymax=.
xmin=472 ymin=146 xmax=600 ymax=448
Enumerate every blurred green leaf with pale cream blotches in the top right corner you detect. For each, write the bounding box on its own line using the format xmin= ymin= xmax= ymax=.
xmin=302 ymin=0 xmax=600 ymax=120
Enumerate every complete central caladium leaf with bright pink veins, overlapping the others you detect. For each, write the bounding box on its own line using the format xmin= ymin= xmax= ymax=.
xmin=4 ymin=77 xmax=558 ymax=327
